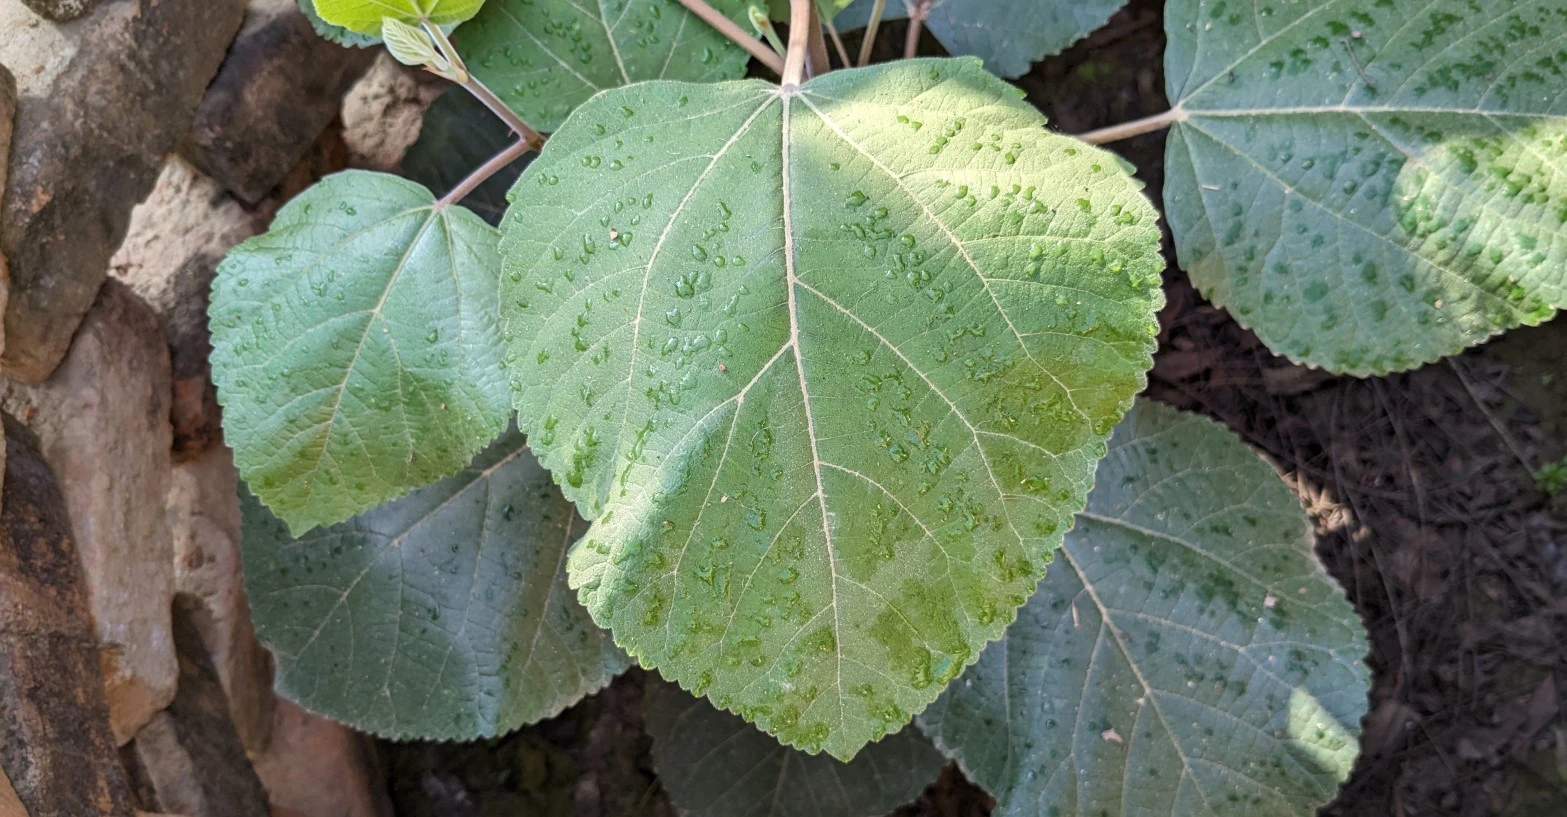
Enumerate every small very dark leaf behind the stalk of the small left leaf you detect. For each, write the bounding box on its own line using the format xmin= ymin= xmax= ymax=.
xmin=403 ymin=86 xmax=534 ymax=224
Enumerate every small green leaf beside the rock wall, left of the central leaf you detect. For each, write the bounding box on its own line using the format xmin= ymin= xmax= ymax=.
xmin=210 ymin=171 xmax=509 ymax=532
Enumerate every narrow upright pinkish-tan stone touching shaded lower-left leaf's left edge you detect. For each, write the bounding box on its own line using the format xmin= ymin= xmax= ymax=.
xmin=168 ymin=445 xmax=276 ymax=753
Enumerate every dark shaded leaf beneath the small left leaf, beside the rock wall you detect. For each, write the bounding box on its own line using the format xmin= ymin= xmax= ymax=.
xmin=241 ymin=431 xmax=627 ymax=740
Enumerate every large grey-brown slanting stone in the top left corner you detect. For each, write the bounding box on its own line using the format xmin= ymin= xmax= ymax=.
xmin=0 ymin=0 xmax=244 ymax=383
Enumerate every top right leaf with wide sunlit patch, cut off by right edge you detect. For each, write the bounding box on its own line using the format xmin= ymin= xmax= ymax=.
xmin=1164 ymin=0 xmax=1567 ymax=375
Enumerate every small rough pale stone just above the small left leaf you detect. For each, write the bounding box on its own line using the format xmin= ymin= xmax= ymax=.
xmin=343 ymin=49 xmax=450 ymax=171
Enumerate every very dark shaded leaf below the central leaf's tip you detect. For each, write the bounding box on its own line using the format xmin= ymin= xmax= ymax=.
xmin=644 ymin=679 xmax=946 ymax=817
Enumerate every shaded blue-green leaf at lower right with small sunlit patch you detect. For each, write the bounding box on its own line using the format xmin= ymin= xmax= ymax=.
xmin=920 ymin=403 xmax=1370 ymax=817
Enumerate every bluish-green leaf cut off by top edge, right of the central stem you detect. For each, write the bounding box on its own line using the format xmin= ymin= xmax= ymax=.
xmin=834 ymin=0 xmax=1127 ymax=77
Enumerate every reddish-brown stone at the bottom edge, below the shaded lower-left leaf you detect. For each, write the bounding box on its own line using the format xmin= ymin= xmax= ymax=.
xmin=251 ymin=699 xmax=392 ymax=817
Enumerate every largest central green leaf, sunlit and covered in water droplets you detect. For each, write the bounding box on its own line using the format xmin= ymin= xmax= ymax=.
xmin=501 ymin=60 xmax=1163 ymax=759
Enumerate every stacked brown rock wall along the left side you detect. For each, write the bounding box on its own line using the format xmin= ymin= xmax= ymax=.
xmin=0 ymin=0 xmax=439 ymax=817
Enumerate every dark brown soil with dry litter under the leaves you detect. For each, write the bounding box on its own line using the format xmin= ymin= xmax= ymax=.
xmin=384 ymin=0 xmax=1567 ymax=817
